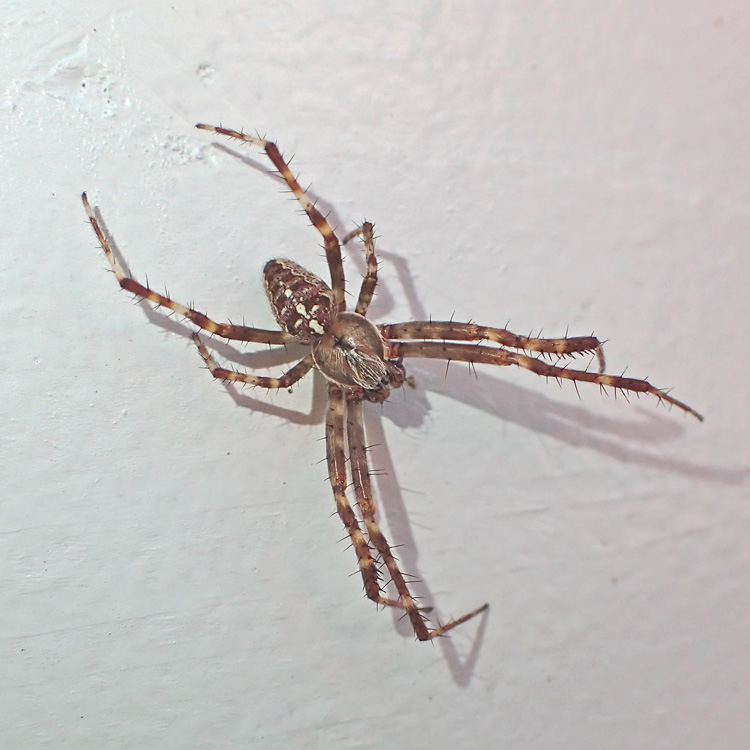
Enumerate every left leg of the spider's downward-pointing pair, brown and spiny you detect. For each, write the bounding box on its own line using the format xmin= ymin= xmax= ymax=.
xmin=326 ymin=383 xmax=391 ymax=604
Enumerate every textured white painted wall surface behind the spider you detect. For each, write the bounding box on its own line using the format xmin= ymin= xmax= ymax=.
xmin=0 ymin=0 xmax=750 ymax=750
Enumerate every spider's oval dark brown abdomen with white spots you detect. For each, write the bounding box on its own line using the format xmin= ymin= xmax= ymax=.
xmin=263 ymin=258 xmax=337 ymax=343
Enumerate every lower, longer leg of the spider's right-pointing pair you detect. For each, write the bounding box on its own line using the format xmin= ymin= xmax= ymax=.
xmin=389 ymin=341 xmax=703 ymax=422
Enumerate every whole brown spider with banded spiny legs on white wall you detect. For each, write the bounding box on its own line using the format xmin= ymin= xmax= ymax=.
xmin=82 ymin=124 xmax=703 ymax=641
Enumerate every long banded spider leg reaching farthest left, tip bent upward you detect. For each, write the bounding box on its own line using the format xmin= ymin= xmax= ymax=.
xmin=81 ymin=193 xmax=294 ymax=344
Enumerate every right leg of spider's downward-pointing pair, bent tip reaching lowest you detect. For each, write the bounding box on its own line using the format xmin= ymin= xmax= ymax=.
xmin=346 ymin=397 xmax=488 ymax=641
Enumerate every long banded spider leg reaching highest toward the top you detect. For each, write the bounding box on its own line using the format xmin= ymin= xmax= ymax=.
xmin=195 ymin=123 xmax=346 ymax=310
